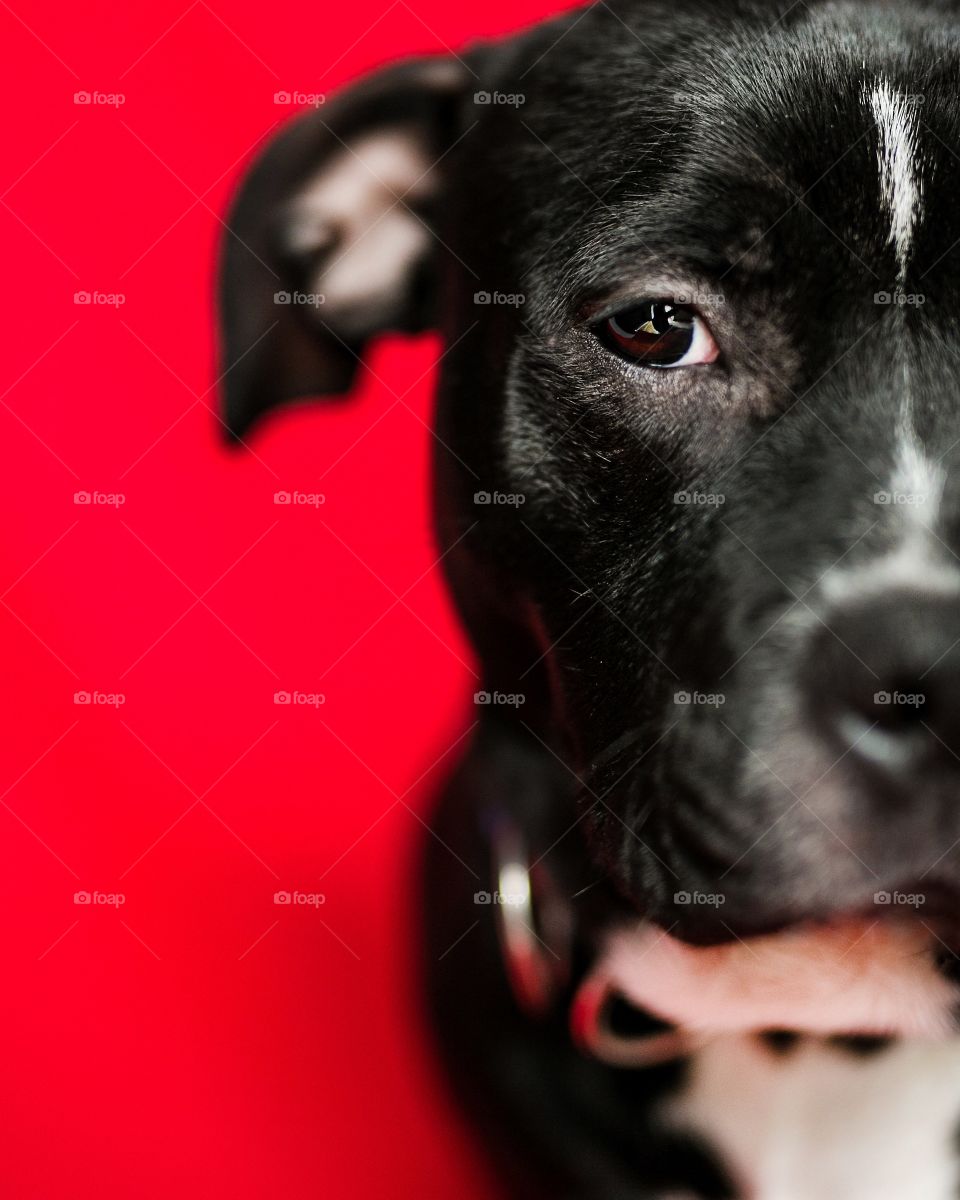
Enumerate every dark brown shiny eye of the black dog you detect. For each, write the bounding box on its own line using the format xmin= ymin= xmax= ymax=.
xmin=595 ymin=300 xmax=720 ymax=367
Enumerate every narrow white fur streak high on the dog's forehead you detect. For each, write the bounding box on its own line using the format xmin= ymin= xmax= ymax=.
xmin=868 ymin=79 xmax=922 ymax=282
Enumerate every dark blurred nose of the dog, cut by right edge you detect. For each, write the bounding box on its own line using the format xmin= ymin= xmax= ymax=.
xmin=805 ymin=589 xmax=960 ymax=775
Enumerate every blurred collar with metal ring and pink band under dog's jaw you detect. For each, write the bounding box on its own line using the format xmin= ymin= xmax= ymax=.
xmin=492 ymin=815 xmax=960 ymax=1068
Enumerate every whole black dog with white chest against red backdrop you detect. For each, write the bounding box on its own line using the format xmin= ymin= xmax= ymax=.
xmin=222 ymin=0 xmax=960 ymax=1200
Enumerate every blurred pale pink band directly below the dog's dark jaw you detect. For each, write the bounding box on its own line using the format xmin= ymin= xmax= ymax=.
xmin=596 ymin=912 xmax=960 ymax=1039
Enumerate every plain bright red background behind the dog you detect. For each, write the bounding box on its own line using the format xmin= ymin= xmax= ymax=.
xmin=0 ymin=0 xmax=578 ymax=1200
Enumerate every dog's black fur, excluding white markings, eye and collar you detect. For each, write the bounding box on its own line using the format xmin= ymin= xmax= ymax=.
xmin=223 ymin=0 xmax=960 ymax=1200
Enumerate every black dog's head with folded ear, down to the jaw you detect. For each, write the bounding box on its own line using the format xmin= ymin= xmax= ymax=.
xmin=224 ymin=0 xmax=960 ymax=955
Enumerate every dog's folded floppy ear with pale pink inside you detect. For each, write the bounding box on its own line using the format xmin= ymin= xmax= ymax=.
xmin=220 ymin=58 xmax=470 ymax=438
